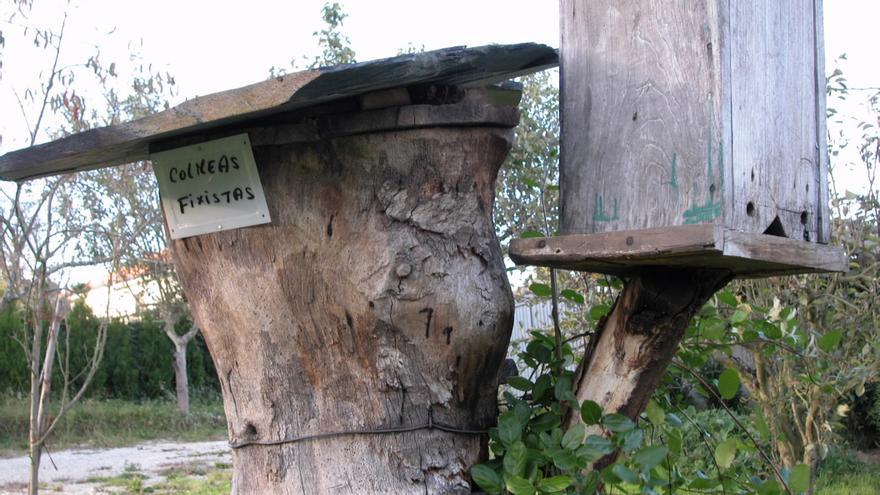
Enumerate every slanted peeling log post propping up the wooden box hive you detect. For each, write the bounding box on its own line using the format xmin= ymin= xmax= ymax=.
xmin=569 ymin=269 xmax=732 ymax=467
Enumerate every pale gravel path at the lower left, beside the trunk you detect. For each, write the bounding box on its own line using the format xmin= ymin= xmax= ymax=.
xmin=0 ymin=441 xmax=232 ymax=495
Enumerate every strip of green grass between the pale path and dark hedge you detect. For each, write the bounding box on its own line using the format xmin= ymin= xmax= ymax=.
xmin=0 ymin=397 xmax=226 ymax=457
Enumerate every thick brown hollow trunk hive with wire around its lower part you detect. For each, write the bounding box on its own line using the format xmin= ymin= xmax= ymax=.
xmin=167 ymin=104 xmax=513 ymax=493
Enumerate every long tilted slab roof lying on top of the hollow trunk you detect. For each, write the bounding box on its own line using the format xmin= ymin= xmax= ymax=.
xmin=0 ymin=43 xmax=558 ymax=180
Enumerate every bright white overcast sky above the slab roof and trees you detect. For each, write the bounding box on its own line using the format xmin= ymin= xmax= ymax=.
xmin=0 ymin=0 xmax=880 ymax=152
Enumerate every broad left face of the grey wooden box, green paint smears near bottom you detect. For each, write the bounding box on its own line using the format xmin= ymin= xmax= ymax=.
xmin=561 ymin=0 xmax=725 ymax=234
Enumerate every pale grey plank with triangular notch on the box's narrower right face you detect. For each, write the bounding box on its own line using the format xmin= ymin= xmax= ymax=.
xmin=730 ymin=0 xmax=824 ymax=241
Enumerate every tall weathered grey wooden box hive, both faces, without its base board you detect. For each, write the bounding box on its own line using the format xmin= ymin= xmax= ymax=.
xmin=561 ymin=0 xmax=830 ymax=256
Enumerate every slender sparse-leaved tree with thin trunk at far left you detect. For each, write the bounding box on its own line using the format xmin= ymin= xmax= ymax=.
xmin=0 ymin=1 xmax=174 ymax=494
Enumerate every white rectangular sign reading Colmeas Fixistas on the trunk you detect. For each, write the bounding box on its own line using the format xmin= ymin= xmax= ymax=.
xmin=150 ymin=134 xmax=271 ymax=239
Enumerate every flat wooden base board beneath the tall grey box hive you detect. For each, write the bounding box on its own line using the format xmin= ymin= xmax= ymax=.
xmin=510 ymin=224 xmax=848 ymax=278
